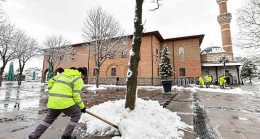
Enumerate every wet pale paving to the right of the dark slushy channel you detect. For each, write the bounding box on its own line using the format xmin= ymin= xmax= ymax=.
xmin=197 ymin=92 xmax=260 ymax=139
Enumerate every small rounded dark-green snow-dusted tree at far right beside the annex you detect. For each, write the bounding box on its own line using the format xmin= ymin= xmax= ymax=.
xmin=241 ymin=61 xmax=258 ymax=83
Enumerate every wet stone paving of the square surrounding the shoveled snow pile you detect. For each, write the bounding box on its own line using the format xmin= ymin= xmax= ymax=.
xmin=0 ymin=82 xmax=260 ymax=139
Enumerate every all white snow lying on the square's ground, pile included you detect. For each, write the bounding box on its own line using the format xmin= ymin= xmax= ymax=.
xmin=0 ymin=79 xmax=260 ymax=139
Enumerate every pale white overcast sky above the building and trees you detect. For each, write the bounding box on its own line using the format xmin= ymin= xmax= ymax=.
xmin=3 ymin=0 xmax=243 ymax=69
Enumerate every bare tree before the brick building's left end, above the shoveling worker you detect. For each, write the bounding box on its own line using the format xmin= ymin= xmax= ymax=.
xmin=43 ymin=35 xmax=73 ymax=79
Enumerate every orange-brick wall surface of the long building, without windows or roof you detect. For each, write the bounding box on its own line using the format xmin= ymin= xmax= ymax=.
xmin=43 ymin=34 xmax=201 ymax=84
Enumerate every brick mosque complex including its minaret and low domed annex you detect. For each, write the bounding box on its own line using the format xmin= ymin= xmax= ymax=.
xmin=42 ymin=0 xmax=241 ymax=85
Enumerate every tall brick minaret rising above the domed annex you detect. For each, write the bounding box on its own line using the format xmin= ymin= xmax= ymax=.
xmin=217 ymin=0 xmax=233 ymax=60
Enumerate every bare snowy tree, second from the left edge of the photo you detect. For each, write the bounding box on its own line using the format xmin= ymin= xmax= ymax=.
xmin=14 ymin=30 xmax=40 ymax=85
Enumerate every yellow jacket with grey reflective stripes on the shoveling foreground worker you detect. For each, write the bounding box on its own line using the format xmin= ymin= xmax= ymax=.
xmin=47 ymin=69 xmax=85 ymax=109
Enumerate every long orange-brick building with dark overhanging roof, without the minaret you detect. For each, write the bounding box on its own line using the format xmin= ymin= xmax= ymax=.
xmin=42 ymin=31 xmax=204 ymax=85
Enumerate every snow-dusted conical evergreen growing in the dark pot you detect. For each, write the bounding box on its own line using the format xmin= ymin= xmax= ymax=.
xmin=159 ymin=45 xmax=173 ymax=80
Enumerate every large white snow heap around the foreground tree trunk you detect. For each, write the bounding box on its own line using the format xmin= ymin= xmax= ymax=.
xmin=80 ymin=98 xmax=189 ymax=139
